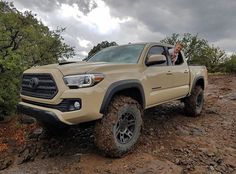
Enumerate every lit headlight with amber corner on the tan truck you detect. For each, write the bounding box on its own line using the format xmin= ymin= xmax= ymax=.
xmin=64 ymin=74 xmax=104 ymax=88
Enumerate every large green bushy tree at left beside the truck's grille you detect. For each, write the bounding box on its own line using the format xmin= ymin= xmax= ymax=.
xmin=0 ymin=1 xmax=74 ymax=117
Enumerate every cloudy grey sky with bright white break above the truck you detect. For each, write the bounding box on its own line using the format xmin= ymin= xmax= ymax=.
xmin=7 ymin=0 xmax=236 ymax=59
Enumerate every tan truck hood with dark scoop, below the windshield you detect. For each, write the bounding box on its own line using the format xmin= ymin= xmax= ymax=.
xmin=29 ymin=61 xmax=138 ymax=76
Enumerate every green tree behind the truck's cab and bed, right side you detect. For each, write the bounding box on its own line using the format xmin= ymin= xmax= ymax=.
xmin=161 ymin=33 xmax=227 ymax=72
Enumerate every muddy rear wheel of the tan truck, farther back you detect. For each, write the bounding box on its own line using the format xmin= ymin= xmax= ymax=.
xmin=184 ymin=86 xmax=204 ymax=117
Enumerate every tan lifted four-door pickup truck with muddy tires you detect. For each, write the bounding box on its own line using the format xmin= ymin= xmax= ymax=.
xmin=18 ymin=43 xmax=207 ymax=157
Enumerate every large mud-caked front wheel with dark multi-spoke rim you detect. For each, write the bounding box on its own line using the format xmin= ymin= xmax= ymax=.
xmin=94 ymin=96 xmax=143 ymax=157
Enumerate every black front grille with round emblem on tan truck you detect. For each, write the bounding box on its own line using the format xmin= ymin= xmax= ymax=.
xmin=21 ymin=74 xmax=58 ymax=99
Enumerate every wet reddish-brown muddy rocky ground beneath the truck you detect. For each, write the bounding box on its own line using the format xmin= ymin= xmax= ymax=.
xmin=0 ymin=75 xmax=236 ymax=174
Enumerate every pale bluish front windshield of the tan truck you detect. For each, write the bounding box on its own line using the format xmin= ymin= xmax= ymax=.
xmin=88 ymin=44 xmax=145 ymax=63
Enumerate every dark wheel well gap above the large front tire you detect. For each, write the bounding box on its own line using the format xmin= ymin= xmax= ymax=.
xmin=115 ymin=88 xmax=145 ymax=107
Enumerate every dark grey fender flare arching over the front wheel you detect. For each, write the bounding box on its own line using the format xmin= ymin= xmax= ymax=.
xmin=100 ymin=79 xmax=146 ymax=114
